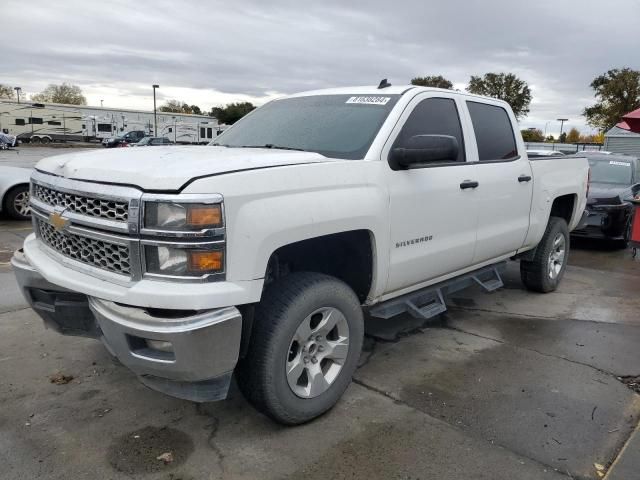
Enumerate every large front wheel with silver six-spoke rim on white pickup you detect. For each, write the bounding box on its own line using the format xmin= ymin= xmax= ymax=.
xmin=236 ymin=272 xmax=364 ymax=425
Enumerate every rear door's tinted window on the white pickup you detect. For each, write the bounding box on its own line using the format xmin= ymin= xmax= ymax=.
xmin=467 ymin=101 xmax=518 ymax=162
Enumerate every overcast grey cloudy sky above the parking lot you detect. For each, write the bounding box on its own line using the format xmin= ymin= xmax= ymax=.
xmin=0 ymin=0 xmax=640 ymax=135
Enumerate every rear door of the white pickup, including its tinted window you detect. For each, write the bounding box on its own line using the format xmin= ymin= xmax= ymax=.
xmin=465 ymin=100 xmax=534 ymax=264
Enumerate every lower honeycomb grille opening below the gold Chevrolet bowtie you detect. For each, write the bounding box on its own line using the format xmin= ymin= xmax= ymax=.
xmin=36 ymin=220 xmax=131 ymax=276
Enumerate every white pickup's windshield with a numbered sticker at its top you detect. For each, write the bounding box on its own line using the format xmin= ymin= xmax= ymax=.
xmin=211 ymin=94 xmax=399 ymax=160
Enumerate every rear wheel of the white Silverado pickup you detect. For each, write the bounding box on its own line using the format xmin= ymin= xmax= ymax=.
xmin=520 ymin=217 xmax=569 ymax=293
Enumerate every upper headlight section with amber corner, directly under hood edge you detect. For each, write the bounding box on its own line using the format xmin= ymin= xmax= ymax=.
xmin=144 ymin=202 xmax=223 ymax=231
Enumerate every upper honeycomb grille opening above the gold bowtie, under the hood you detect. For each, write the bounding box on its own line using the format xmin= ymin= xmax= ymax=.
xmin=33 ymin=183 xmax=129 ymax=223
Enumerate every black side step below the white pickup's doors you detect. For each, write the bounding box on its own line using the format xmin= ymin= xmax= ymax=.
xmin=369 ymin=261 xmax=507 ymax=320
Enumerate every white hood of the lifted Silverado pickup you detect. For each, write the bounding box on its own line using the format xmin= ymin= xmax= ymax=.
xmin=36 ymin=146 xmax=335 ymax=191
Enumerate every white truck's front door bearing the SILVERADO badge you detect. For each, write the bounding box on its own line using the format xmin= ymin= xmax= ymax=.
xmin=383 ymin=92 xmax=478 ymax=292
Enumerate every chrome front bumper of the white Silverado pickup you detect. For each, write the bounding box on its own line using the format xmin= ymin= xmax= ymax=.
xmin=11 ymin=251 xmax=242 ymax=402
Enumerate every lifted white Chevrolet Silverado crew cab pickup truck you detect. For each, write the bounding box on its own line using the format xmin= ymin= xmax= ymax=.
xmin=12 ymin=83 xmax=589 ymax=424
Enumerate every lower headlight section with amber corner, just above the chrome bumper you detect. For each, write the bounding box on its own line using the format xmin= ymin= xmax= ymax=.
xmin=145 ymin=245 xmax=224 ymax=277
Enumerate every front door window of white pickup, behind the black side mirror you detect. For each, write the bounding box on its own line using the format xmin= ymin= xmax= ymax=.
xmin=396 ymin=98 xmax=466 ymax=162
